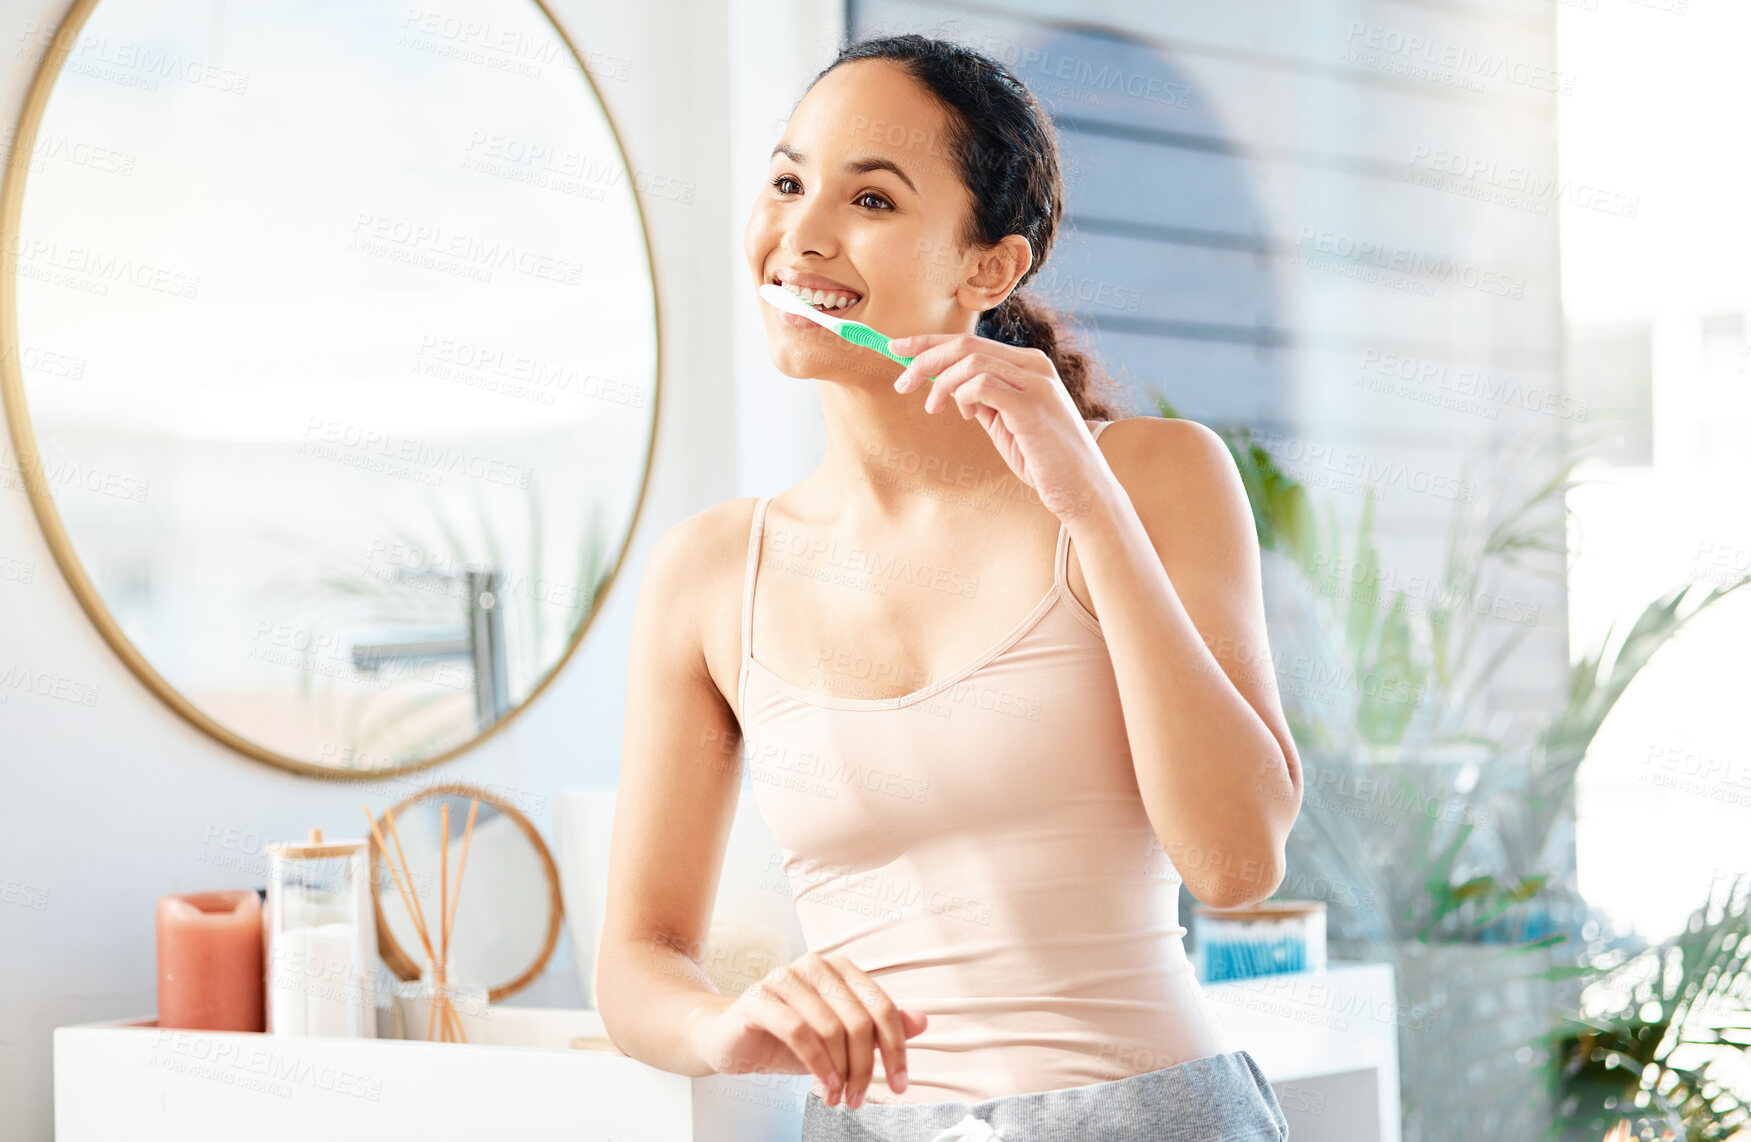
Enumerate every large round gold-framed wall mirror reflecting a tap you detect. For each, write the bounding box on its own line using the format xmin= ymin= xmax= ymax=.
xmin=0 ymin=0 xmax=658 ymax=778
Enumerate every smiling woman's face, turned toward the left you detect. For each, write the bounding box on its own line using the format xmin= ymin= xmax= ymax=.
xmin=742 ymin=60 xmax=1002 ymax=380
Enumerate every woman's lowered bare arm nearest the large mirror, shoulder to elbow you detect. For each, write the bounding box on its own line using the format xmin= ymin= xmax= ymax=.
xmin=595 ymin=508 xmax=746 ymax=1075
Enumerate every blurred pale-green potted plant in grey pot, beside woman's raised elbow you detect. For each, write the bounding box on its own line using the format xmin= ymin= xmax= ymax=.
xmin=1156 ymin=396 xmax=1751 ymax=1142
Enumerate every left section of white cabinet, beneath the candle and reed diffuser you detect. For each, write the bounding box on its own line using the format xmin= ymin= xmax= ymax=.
xmin=54 ymin=1005 xmax=809 ymax=1142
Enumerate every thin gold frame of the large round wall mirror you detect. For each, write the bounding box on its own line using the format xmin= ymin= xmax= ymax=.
xmin=0 ymin=0 xmax=662 ymax=777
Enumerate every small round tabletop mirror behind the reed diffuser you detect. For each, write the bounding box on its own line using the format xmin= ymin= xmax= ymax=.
xmin=371 ymin=783 xmax=564 ymax=1004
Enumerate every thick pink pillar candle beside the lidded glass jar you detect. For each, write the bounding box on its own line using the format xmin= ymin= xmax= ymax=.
xmin=158 ymin=888 xmax=266 ymax=1032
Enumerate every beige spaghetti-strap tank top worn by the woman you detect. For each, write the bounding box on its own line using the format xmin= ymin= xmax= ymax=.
xmin=737 ymin=422 xmax=1233 ymax=1102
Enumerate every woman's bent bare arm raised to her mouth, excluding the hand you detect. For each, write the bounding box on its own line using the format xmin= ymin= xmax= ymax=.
xmin=1068 ymin=417 xmax=1301 ymax=907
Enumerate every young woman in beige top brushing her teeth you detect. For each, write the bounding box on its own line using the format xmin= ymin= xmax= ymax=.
xmin=597 ymin=35 xmax=1301 ymax=1142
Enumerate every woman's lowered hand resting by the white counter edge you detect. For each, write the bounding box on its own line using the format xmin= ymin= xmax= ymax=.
xmin=686 ymin=951 xmax=928 ymax=1107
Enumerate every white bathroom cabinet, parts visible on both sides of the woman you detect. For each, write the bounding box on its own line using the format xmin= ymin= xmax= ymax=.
xmin=54 ymin=963 xmax=1400 ymax=1142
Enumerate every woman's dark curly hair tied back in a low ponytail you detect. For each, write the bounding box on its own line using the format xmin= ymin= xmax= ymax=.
xmin=809 ymin=35 xmax=1119 ymax=420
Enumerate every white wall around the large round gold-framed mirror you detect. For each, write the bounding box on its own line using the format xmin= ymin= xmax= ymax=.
xmin=0 ymin=0 xmax=840 ymax=1142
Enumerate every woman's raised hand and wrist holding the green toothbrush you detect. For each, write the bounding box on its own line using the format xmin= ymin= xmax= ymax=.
xmin=888 ymin=333 xmax=1110 ymax=520
